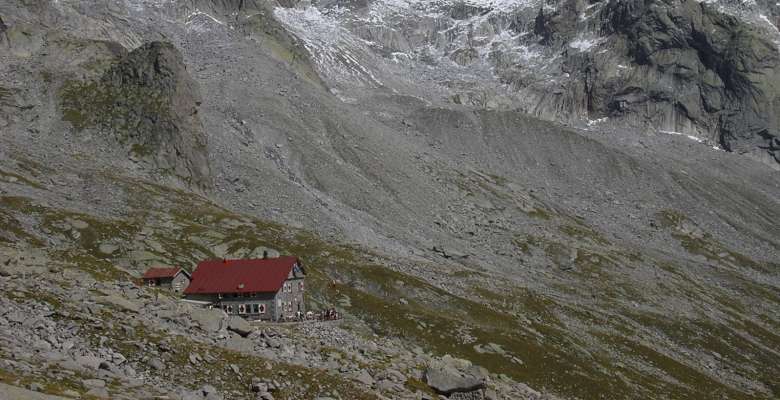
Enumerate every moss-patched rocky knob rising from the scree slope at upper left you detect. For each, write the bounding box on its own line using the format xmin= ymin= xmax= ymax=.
xmin=61 ymin=42 xmax=211 ymax=188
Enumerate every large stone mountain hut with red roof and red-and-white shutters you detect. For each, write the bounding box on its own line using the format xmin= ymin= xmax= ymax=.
xmin=184 ymin=256 xmax=306 ymax=321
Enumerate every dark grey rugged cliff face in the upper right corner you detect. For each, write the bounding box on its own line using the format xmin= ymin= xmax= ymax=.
xmin=593 ymin=0 xmax=780 ymax=161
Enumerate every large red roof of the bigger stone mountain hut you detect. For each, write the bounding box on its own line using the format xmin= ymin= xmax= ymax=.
xmin=184 ymin=256 xmax=298 ymax=294
